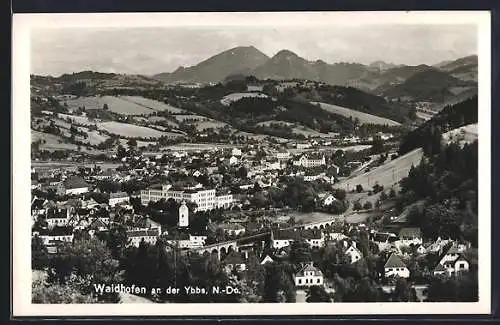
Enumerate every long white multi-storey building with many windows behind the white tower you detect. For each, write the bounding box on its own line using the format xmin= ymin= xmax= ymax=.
xmin=141 ymin=185 xmax=233 ymax=211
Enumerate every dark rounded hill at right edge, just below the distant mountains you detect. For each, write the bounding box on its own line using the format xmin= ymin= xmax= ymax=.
xmin=382 ymin=69 xmax=477 ymax=102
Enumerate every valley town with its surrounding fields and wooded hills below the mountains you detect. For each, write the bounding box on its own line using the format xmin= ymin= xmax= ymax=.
xmin=31 ymin=48 xmax=478 ymax=302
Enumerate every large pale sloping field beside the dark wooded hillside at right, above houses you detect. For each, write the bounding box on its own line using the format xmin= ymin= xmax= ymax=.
xmin=335 ymin=148 xmax=423 ymax=191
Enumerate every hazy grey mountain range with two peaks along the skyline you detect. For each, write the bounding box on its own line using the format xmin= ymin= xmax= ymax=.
xmin=153 ymin=46 xmax=477 ymax=94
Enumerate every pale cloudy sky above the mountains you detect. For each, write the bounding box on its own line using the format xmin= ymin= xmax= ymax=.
xmin=31 ymin=24 xmax=477 ymax=76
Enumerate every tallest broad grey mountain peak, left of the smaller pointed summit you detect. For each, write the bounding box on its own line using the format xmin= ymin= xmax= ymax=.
xmin=153 ymin=46 xmax=269 ymax=83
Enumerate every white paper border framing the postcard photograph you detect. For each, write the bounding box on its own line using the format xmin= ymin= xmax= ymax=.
xmin=12 ymin=11 xmax=491 ymax=316
